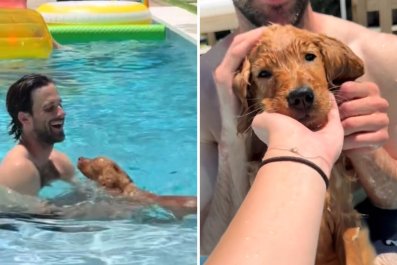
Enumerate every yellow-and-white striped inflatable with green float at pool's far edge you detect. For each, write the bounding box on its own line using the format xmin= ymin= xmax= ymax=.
xmin=37 ymin=1 xmax=166 ymax=44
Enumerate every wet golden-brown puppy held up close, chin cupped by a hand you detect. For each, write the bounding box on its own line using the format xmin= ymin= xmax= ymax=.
xmin=202 ymin=25 xmax=375 ymax=265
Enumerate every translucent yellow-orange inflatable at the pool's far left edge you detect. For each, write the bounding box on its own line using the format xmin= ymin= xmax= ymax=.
xmin=0 ymin=8 xmax=52 ymax=59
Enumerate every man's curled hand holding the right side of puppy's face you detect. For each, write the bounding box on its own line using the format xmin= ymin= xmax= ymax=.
xmin=336 ymin=82 xmax=389 ymax=156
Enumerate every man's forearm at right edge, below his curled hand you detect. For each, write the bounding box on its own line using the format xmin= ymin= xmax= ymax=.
xmin=350 ymin=148 xmax=397 ymax=209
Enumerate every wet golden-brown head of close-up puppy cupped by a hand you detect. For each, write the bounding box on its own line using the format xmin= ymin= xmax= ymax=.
xmin=233 ymin=25 xmax=364 ymax=133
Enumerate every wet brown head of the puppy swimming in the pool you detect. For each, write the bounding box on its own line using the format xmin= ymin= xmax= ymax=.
xmin=77 ymin=157 xmax=132 ymax=194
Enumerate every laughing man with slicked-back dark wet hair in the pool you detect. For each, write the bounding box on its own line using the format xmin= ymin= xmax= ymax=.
xmin=0 ymin=74 xmax=74 ymax=195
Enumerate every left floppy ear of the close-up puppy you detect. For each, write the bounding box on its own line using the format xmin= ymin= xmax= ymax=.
xmin=233 ymin=58 xmax=251 ymax=133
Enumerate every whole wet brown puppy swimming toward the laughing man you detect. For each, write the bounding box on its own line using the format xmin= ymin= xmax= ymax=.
xmin=77 ymin=157 xmax=197 ymax=218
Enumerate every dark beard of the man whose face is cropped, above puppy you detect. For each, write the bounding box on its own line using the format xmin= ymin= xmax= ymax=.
xmin=233 ymin=0 xmax=309 ymax=27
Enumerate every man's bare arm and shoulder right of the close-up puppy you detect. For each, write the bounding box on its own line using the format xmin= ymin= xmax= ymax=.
xmin=341 ymin=31 xmax=397 ymax=209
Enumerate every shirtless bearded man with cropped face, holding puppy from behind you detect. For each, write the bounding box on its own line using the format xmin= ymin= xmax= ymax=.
xmin=200 ymin=0 xmax=397 ymax=258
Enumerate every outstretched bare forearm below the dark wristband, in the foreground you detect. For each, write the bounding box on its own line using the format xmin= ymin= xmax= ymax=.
xmin=207 ymin=162 xmax=325 ymax=265
